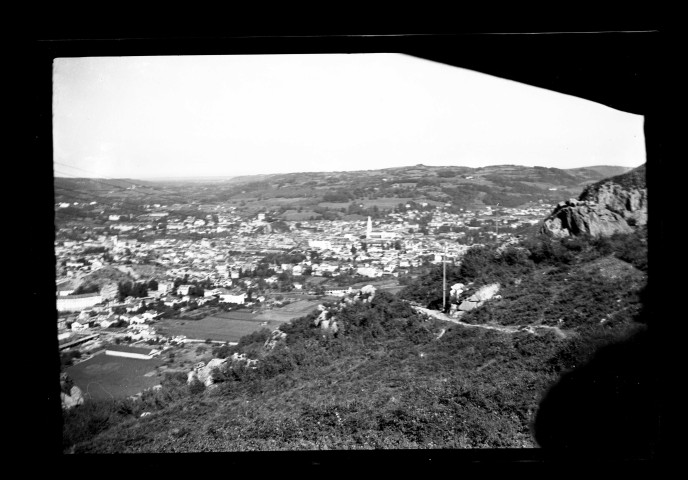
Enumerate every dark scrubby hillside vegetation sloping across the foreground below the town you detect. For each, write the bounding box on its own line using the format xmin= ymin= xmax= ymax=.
xmin=63 ymin=231 xmax=647 ymax=453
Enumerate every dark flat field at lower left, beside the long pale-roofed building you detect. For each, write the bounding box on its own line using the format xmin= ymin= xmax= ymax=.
xmin=67 ymin=353 xmax=162 ymax=399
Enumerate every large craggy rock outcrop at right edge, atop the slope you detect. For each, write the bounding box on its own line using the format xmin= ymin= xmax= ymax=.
xmin=542 ymin=165 xmax=647 ymax=238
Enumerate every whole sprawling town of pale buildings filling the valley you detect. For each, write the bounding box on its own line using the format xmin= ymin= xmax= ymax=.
xmin=55 ymin=199 xmax=551 ymax=348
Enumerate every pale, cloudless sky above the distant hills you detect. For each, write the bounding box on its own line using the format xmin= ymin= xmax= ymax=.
xmin=53 ymin=53 xmax=645 ymax=179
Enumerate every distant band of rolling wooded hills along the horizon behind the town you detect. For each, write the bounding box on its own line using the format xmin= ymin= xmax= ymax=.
xmin=55 ymin=164 xmax=640 ymax=221
